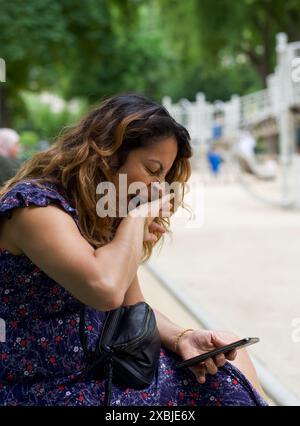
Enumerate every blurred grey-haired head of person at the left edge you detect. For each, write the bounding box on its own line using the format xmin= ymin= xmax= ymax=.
xmin=0 ymin=128 xmax=21 ymax=186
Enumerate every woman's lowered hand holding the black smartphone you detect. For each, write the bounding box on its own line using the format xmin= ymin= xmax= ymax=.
xmin=178 ymin=329 xmax=238 ymax=383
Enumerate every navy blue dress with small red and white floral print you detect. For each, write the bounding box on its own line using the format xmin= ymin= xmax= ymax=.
xmin=0 ymin=179 xmax=268 ymax=406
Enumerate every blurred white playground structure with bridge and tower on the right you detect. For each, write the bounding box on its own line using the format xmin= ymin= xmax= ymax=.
xmin=162 ymin=33 xmax=300 ymax=208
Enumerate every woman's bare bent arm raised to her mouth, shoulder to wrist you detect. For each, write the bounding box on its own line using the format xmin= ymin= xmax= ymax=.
xmin=9 ymin=205 xmax=145 ymax=310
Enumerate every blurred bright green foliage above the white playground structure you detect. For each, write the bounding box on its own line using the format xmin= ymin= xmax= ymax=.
xmin=156 ymin=0 xmax=300 ymax=94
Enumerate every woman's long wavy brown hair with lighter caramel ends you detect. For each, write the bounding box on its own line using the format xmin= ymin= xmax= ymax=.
xmin=0 ymin=92 xmax=192 ymax=261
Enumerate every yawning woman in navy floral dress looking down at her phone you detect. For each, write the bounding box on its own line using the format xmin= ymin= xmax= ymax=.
xmin=0 ymin=93 xmax=267 ymax=405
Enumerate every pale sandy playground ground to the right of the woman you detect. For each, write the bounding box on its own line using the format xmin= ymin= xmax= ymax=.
xmin=145 ymin=170 xmax=300 ymax=397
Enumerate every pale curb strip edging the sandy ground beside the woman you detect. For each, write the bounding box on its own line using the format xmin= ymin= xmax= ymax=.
xmin=143 ymin=262 xmax=300 ymax=406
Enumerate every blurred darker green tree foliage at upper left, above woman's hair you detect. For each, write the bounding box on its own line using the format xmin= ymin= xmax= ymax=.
xmin=0 ymin=0 xmax=172 ymax=126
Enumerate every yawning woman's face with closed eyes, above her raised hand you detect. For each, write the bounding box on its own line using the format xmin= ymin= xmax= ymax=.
xmin=113 ymin=137 xmax=177 ymax=207
